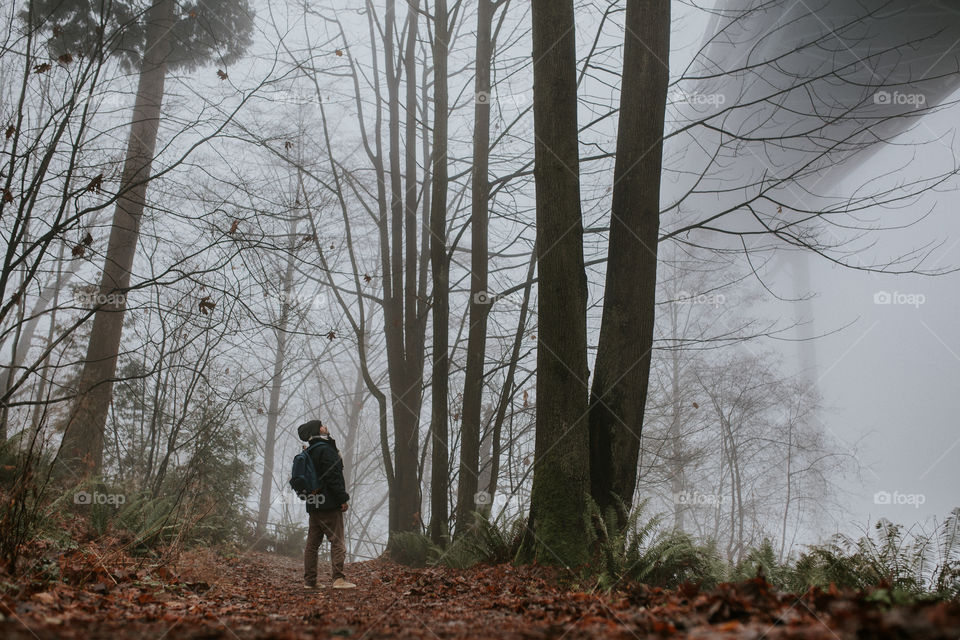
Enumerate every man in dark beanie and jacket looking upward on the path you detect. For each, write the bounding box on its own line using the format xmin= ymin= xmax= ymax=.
xmin=297 ymin=420 xmax=357 ymax=589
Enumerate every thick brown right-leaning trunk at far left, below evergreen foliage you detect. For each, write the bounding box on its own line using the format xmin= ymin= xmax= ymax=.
xmin=61 ymin=0 xmax=174 ymax=474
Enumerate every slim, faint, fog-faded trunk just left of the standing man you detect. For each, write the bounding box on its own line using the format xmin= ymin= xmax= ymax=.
xmin=255 ymin=221 xmax=297 ymax=541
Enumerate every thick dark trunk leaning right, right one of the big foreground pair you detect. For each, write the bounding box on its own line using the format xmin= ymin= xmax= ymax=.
xmin=590 ymin=0 xmax=670 ymax=520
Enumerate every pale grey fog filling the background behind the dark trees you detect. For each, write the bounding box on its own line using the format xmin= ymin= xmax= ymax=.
xmin=0 ymin=0 xmax=960 ymax=560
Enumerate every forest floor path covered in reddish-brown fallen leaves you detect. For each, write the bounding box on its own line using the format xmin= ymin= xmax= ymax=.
xmin=0 ymin=550 xmax=960 ymax=640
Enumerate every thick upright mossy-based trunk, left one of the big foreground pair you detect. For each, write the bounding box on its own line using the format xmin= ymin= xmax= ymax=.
xmin=523 ymin=0 xmax=590 ymax=566
